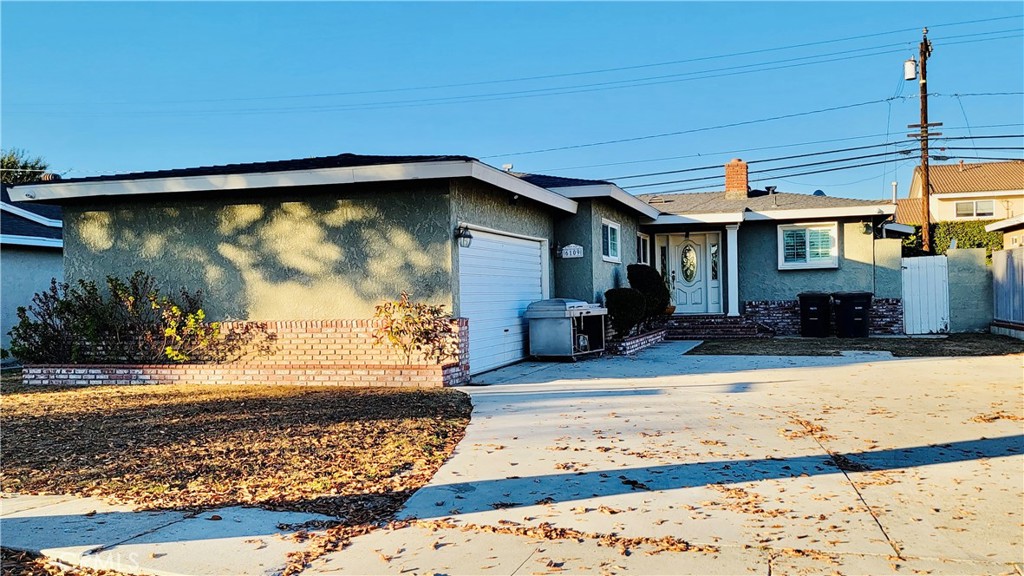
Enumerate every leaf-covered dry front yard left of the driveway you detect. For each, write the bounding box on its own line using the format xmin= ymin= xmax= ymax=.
xmin=0 ymin=378 xmax=470 ymax=523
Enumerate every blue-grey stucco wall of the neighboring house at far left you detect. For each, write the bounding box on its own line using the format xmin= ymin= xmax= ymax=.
xmin=0 ymin=244 xmax=63 ymax=348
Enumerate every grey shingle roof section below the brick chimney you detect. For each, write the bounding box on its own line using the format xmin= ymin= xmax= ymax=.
xmin=637 ymin=192 xmax=889 ymax=214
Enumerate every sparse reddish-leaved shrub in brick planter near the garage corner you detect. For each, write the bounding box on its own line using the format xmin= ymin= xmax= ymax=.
xmin=374 ymin=291 xmax=459 ymax=364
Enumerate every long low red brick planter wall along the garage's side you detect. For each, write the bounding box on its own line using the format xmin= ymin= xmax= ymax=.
xmin=22 ymin=318 xmax=469 ymax=387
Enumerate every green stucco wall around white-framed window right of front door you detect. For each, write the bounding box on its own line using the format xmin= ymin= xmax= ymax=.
xmin=738 ymin=220 xmax=901 ymax=302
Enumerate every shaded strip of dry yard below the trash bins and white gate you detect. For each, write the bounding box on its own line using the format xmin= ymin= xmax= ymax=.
xmin=688 ymin=334 xmax=1024 ymax=357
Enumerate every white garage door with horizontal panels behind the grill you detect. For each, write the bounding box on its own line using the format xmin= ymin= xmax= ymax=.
xmin=459 ymin=230 xmax=544 ymax=374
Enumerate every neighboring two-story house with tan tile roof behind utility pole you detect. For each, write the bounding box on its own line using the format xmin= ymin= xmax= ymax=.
xmin=897 ymin=161 xmax=1024 ymax=224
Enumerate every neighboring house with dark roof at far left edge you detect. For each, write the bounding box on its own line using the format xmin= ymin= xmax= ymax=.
xmin=0 ymin=186 xmax=63 ymax=348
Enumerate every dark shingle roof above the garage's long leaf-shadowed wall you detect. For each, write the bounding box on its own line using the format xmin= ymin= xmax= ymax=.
xmin=12 ymin=154 xmax=476 ymax=186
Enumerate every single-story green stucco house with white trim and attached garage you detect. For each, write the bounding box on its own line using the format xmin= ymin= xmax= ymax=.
xmin=12 ymin=154 xmax=901 ymax=373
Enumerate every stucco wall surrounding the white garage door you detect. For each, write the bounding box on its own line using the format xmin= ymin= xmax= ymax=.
xmin=450 ymin=178 xmax=557 ymax=313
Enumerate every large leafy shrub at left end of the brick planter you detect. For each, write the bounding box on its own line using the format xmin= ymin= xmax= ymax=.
xmin=4 ymin=272 xmax=274 ymax=364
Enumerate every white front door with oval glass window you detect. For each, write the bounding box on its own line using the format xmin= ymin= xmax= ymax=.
xmin=667 ymin=233 xmax=722 ymax=314
